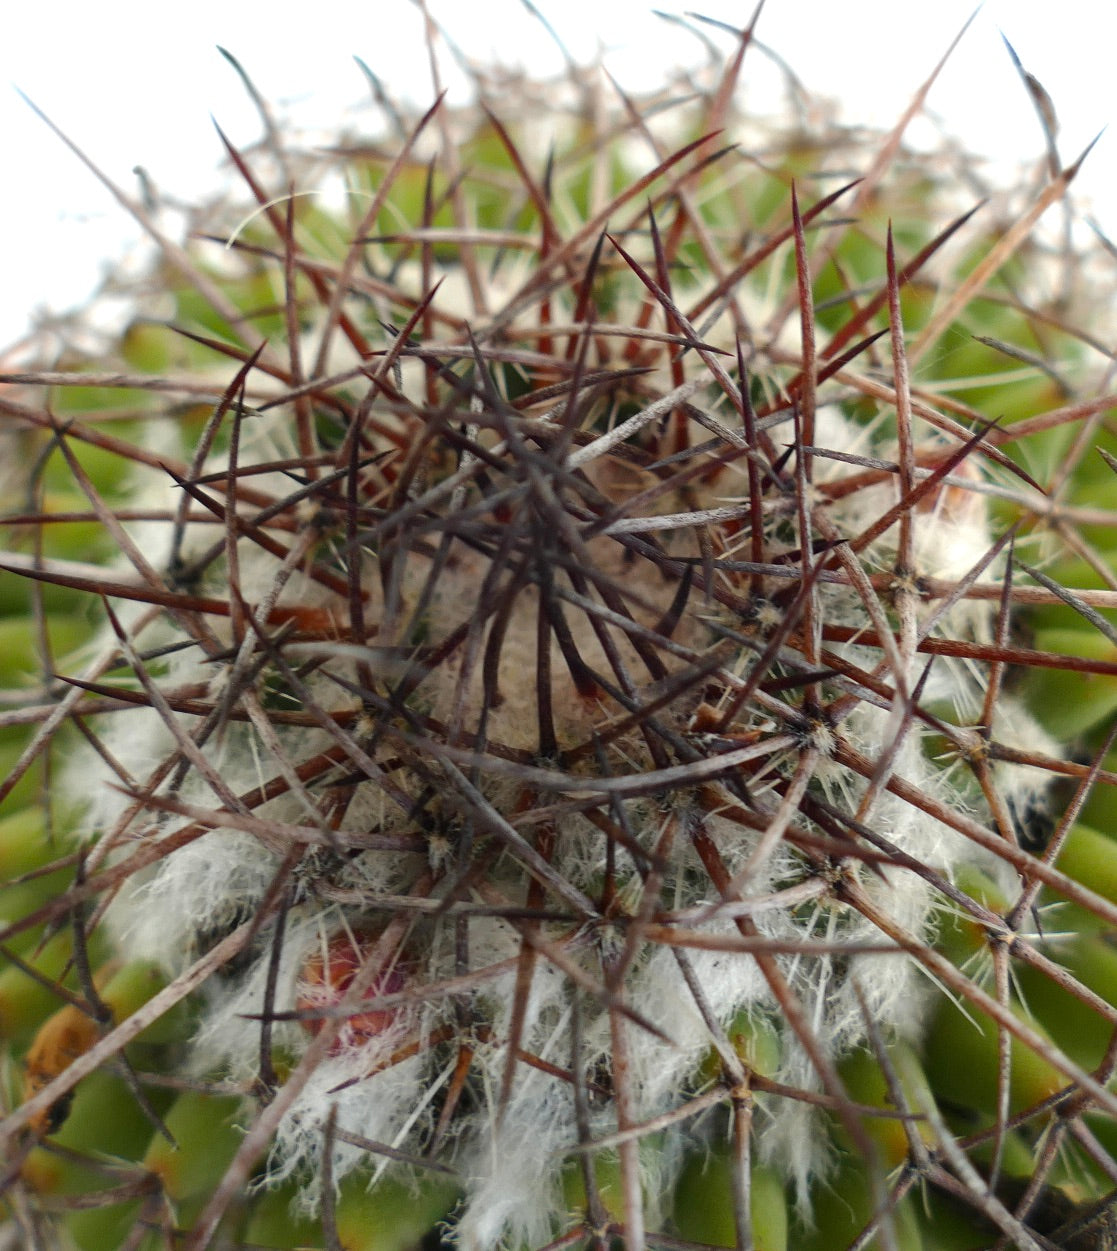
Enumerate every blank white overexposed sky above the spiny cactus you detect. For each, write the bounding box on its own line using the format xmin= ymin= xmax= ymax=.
xmin=0 ymin=0 xmax=1117 ymax=348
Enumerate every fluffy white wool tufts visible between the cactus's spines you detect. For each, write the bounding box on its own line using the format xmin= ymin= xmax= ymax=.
xmin=69 ymin=362 xmax=1036 ymax=1251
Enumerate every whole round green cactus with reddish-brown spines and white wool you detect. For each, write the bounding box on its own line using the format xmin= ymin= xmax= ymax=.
xmin=0 ymin=9 xmax=1117 ymax=1251
